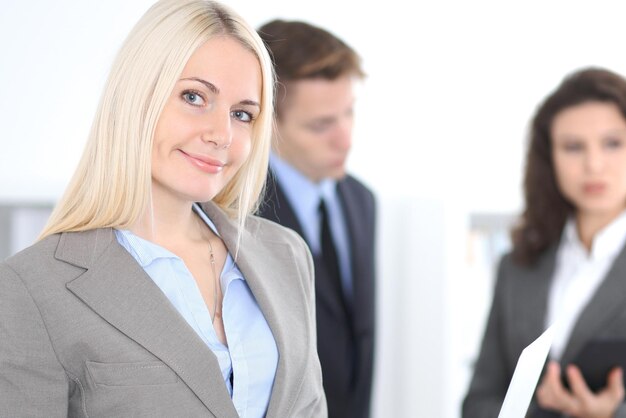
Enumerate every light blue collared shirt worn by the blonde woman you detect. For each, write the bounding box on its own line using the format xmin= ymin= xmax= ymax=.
xmin=115 ymin=205 xmax=278 ymax=418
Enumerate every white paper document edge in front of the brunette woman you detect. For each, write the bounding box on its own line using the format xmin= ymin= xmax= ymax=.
xmin=498 ymin=325 xmax=554 ymax=418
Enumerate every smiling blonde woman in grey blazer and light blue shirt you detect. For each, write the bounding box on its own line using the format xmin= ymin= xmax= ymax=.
xmin=0 ymin=0 xmax=326 ymax=417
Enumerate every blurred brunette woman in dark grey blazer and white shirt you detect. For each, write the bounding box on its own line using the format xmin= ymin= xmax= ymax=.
xmin=463 ymin=68 xmax=626 ymax=418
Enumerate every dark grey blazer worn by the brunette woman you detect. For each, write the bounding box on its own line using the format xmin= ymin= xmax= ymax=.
xmin=463 ymin=246 xmax=626 ymax=418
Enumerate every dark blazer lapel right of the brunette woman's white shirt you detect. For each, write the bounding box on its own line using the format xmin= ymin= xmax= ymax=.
xmin=561 ymin=247 xmax=626 ymax=364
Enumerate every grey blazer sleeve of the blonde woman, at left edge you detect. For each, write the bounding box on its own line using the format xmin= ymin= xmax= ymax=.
xmin=0 ymin=263 xmax=69 ymax=417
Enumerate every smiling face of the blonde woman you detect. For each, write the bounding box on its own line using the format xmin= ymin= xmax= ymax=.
xmin=152 ymin=37 xmax=262 ymax=201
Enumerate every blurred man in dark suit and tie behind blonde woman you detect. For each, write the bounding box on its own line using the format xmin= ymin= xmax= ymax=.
xmin=259 ymin=20 xmax=375 ymax=418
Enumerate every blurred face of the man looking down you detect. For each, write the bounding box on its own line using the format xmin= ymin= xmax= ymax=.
xmin=274 ymin=76 xmax=354 ymax=182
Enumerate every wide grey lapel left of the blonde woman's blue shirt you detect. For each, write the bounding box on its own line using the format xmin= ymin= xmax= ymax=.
xmin=56 ymin=228 xmax=237 ymax=418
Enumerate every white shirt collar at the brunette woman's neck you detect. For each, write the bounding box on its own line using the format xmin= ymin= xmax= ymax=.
xmin=563 ymin=211 xmax=626 ymax=260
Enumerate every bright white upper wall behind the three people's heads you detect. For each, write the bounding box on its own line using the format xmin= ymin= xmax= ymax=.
xmin=0 ymin=0 xmax=626 ymax=211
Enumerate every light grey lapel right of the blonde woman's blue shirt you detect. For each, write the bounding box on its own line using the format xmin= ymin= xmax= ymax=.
xmin=202 ymin=203 xmax=315 ymax=417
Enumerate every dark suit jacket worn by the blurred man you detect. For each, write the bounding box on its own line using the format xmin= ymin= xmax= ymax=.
xmin=259 ymin=174 xmax=375 ymax=418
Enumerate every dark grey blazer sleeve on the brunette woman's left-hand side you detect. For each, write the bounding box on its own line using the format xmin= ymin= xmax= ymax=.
xmin=462 ymin=257 xmax=512 ymax=418
